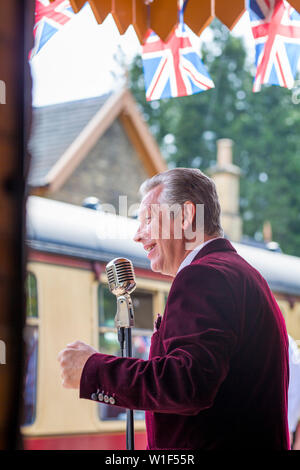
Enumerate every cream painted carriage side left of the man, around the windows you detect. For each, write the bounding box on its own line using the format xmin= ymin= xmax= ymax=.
xmin=22 ymin=262 xmax=169 ymax=436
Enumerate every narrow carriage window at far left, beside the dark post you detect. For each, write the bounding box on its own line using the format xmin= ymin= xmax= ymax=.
xmin=23 ymin=273 xmax=38 ymax=425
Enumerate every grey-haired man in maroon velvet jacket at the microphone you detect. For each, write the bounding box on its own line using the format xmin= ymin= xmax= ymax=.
xmin=59 ymin=168 xmax=289 ymax=450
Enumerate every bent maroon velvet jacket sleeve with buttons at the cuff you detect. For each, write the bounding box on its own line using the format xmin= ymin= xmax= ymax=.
xmin=80 ymin=264 xmax=237 ymax=415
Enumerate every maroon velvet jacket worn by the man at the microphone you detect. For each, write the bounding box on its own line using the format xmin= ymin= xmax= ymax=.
xmin=80 ymin=239 xmax=289 ymax=450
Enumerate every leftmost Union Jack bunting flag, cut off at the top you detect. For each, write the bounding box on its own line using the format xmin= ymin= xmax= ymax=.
xmin=29 ymin=0 xmax=74 ymax=59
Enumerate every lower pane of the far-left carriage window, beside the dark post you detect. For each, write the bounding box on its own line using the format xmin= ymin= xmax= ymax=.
xmin=23 ymin=326 xmax=38 ymax=425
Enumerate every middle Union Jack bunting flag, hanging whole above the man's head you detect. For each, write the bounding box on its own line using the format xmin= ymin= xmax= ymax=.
xmin=142 ymin=2 xmax=214 ymax=101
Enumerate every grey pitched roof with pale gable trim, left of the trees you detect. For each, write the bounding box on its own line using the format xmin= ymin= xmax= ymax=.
xmin=28 ymin=89 xmax=167 ymax=195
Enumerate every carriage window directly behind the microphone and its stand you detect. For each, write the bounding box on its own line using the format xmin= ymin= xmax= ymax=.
xmin=98 ymin=284 xmax=154 ymax=420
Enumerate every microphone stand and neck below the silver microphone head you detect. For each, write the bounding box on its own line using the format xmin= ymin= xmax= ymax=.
xmin=115 ymin=293 xmax=134 ymax=450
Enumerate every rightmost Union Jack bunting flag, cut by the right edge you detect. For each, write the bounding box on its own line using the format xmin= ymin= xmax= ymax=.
xmin=248 ymin=0 xmax=300 ymax=92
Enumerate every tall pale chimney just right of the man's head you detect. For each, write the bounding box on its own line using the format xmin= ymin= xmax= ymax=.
xmin=209 ymin=139 xmax=242 ymax=242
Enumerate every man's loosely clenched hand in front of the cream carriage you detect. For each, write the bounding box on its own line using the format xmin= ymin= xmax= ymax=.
xmin=58 ymin=341 xmax=98 ymax=388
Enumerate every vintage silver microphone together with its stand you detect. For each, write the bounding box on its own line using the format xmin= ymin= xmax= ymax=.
xmin=106 ymin=258 xmax=136 ymax=450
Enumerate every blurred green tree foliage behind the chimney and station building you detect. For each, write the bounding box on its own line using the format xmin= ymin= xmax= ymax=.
xmin=129 ymin=21 xmax=300 ymax=256
